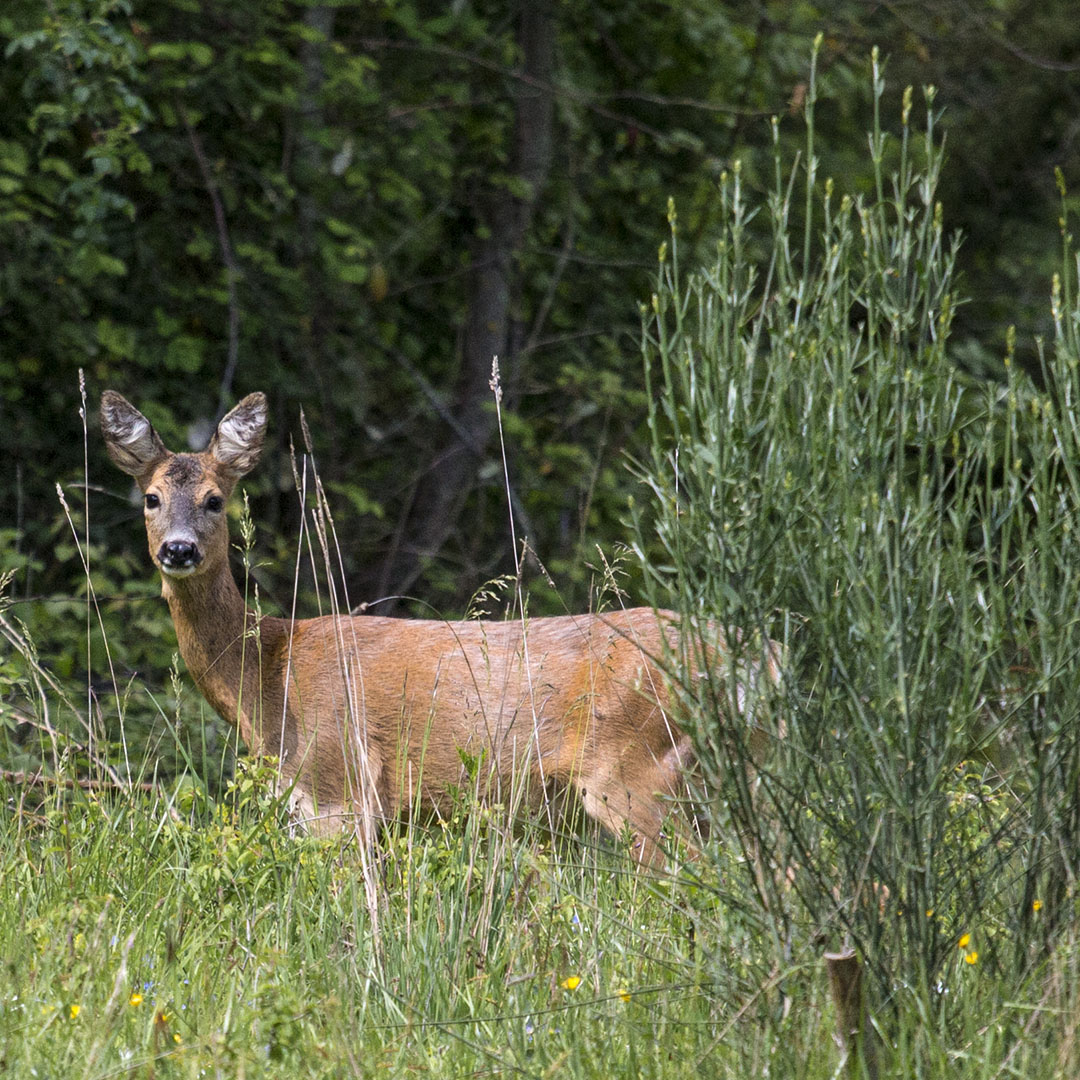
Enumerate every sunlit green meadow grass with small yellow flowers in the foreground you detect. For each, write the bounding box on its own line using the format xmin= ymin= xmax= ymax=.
xmin=0 ymin=766 xmax=1080 ymax=1080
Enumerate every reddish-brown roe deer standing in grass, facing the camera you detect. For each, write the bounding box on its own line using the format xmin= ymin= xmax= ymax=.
xmin=102 ymin=390 xmax=779 ymax=865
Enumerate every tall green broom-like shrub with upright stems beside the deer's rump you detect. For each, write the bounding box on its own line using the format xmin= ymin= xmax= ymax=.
xmin=635 ymin=42 xmax=1080 ymax=1015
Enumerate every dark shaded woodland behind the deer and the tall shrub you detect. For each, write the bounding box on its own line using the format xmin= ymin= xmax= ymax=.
xmin=0 ymin=0 xmax=1080 ymax=672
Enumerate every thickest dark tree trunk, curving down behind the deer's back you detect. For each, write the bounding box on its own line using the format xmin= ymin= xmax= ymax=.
xmin=380 ymin=0 xmax=555 ymax=611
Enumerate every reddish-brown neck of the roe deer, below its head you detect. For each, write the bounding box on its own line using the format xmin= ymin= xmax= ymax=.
xmin=161 ymin=564 xmax=280 ymax=753
